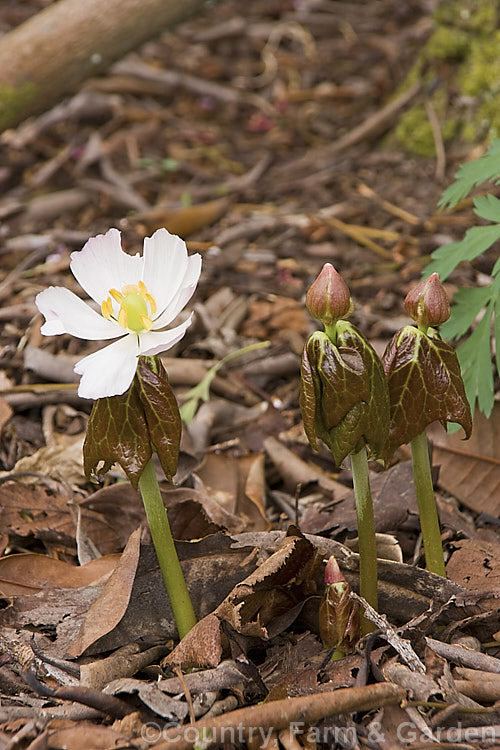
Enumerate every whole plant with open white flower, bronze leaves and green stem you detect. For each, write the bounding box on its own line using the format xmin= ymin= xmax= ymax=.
xmin=36 ymin=229 xmax=201 ymax=638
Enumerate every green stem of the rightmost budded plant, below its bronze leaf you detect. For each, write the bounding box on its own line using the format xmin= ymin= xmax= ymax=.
xmin=411 ymin=431 xmax=446 ymax=578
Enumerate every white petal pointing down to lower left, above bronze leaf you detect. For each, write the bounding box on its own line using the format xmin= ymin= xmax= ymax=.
xmin=75 ymin=333 xmax=139 ymax=399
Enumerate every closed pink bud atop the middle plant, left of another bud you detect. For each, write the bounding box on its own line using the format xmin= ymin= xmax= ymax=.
xmin=306 ymin=263 xmax=353 ymax=326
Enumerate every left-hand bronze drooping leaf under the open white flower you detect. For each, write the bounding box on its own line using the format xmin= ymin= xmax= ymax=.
xmin=83 ymin=380 xmax=151 ymax=489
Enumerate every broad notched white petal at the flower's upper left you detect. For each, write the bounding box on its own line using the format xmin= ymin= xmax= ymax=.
xmin=70 ymin=229 xmax=143 ymax=305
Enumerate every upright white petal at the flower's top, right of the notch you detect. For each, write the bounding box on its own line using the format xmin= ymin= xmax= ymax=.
xmin=142 ymin=229 xmax=188 ymax=313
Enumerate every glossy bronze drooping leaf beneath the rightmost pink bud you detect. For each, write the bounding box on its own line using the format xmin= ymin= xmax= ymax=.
xmin=383 ymin=326 xmax=472 ymax=460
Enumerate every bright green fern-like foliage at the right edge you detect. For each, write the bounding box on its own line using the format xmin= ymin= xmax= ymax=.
xmin=423 ymin=139 xmax=500 ymax=417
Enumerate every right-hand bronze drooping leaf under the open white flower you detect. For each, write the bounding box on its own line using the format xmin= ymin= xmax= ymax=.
xmin=135 ymin=357 xmax=182 ymax=482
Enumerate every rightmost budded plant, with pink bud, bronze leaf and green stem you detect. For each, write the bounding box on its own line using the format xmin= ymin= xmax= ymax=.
xmin=381 ymin=273 xmax=472 ymax=576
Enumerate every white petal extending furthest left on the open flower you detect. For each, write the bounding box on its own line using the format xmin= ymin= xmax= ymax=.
xmin=35 ymin=286 xmax=123 ymax=340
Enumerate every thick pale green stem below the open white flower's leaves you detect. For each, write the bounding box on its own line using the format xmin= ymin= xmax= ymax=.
xmin=139 ymin=459 xmax=196 ymax=638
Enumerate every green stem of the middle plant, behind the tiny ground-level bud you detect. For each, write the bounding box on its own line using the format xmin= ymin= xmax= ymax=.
xmin=351 ymin=445 xmax=378 ymax=634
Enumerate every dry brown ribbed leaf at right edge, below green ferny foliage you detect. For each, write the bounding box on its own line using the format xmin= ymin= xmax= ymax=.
xmin=427 ymin=401 xmax=500 ymax=517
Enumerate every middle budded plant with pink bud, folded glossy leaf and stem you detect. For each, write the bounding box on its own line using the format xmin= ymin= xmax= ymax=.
xmin=300 ymin=263 xmax=389 ymax=632
